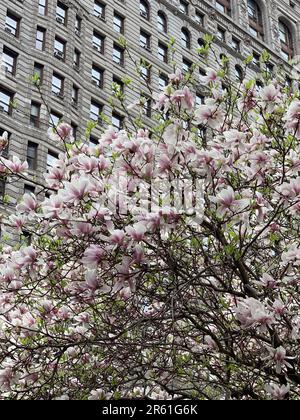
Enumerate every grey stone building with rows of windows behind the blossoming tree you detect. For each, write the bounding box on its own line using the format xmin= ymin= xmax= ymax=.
xmin=0 ymin=0 xmax=300 ymax=233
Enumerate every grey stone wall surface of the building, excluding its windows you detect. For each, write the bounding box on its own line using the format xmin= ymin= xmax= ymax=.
xmin=0 ymin=0 xmax=300 ymax=230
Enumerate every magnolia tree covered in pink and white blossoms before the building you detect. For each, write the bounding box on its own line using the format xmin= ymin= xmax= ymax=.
xmin=0 ymin=53 xmax=300 ymax=400
